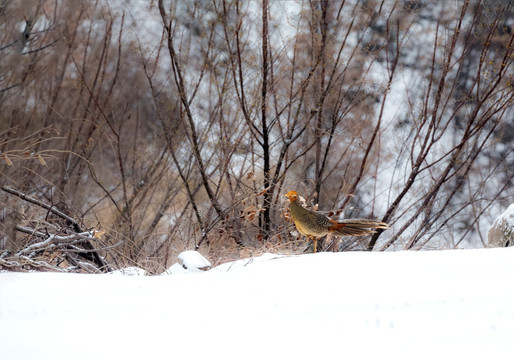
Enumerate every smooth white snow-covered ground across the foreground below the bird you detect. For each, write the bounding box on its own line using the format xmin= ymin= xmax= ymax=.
xmin=0 ymin=248 xmax=514 ymax=359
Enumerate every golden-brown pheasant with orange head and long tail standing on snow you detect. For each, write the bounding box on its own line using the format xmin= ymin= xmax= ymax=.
xmin=285 ymin=191 xmax=389 ymax=252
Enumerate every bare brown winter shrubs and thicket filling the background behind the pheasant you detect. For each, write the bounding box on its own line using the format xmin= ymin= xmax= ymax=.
xmin=0 ymin=0 xmax=514 ymax=274
